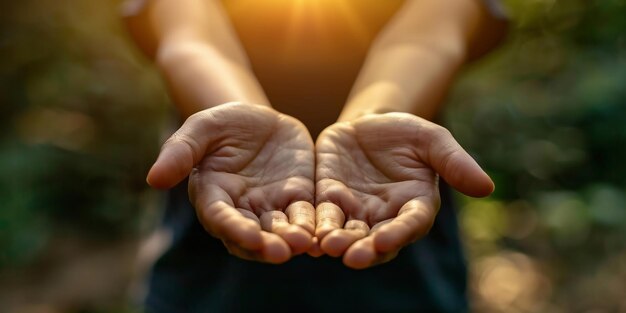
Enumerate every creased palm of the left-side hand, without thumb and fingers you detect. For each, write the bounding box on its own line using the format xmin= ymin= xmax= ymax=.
xmin=190 ymin=105 xmax=314 ymax=222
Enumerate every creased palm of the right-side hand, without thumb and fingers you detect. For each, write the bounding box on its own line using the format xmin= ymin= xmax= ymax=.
xmin=317 ymin=120 xmax=438 ymax=227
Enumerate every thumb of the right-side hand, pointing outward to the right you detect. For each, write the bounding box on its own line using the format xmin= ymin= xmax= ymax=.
xmin=423 ymin=126 xmax=494 ymax=197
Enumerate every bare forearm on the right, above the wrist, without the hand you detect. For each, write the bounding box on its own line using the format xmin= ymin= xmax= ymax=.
xmin=339 ymin=0 xmax=504 ymax=121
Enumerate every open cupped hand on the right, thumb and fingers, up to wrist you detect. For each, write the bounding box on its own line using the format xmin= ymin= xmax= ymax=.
xmin=315 ymin=113 xmax=494 ymax=269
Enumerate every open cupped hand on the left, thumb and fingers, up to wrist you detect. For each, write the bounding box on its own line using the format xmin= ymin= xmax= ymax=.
xmin=147 ymin=103 xmax=315 ymax=263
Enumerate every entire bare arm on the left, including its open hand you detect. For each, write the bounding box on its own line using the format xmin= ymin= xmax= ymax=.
xmin=125 ymin=0 xmax=315 ymax=263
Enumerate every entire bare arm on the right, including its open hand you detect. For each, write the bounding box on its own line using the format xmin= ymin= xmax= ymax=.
xmin=315 ymin=0 xmax=504 ymax=268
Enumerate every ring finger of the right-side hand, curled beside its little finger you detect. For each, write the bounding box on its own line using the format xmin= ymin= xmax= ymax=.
xmin=321 ymin=220 xmax=370 ymax=257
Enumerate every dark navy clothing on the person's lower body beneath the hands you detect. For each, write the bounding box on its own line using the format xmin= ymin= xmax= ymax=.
xmin=146 ymin=183 xmax=467 ymax=313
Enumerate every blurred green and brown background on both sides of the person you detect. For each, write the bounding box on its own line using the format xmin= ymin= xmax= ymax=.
xmin=0 ymin=0 xmax=626 ymax=313
